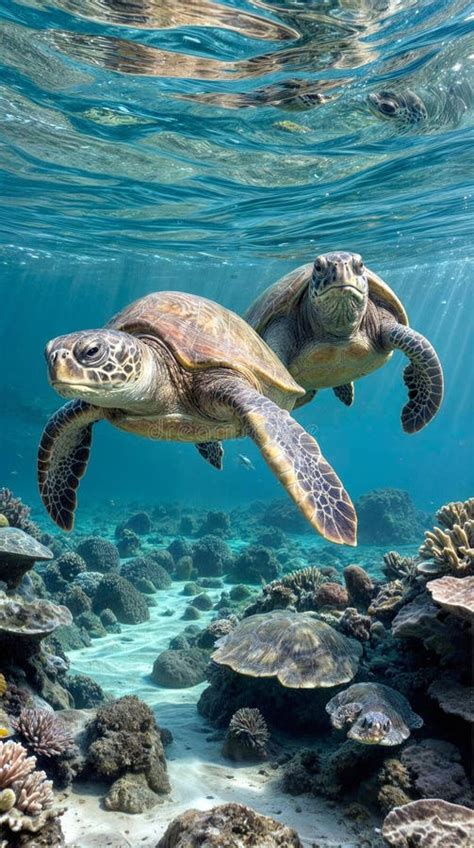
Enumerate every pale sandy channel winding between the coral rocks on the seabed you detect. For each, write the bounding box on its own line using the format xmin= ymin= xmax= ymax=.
xmin=62 ymin=583 xmax=366 ymax=848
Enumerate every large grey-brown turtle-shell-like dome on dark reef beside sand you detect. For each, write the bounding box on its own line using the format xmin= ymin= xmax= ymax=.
xmin=211 ymin=610 xmax=362 ymax=689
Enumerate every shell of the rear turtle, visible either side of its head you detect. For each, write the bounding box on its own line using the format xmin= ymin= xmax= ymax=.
xmin=244 ymin=262 xmax=408 ymax=333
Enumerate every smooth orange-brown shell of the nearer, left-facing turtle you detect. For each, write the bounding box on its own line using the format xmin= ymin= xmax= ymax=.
xmin=107 ymin=291 xmax=304 ymax=399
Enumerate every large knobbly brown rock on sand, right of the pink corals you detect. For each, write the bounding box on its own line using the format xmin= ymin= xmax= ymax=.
xmin=87 ymin=695 xmax=170 ymax=794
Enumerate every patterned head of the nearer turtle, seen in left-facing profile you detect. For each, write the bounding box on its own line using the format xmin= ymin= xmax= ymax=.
xmin=45 ymin=329 xmax=153 ymax=408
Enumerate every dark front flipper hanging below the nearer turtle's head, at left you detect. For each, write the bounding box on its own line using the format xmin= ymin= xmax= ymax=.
xmin=38 ymin=400 xmax=104 ymax=530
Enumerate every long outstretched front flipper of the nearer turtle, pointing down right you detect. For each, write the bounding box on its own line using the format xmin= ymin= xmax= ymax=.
xmin=222 ymin=385 xmax=357 ymax=545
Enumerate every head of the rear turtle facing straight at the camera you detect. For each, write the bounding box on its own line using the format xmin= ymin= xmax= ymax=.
xmin=309 ymin=251 xmax=369 ymax=337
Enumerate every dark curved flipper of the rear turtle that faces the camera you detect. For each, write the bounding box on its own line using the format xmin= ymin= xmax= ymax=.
xmin=382 ymin=324 xmax=443 ymax=433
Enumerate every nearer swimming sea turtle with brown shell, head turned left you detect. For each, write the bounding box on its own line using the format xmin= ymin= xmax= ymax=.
xmin=38 ymin=291 xmax=357 ymax=544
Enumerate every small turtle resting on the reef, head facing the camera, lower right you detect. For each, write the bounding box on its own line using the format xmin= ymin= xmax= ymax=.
xmin=326 ymin=683 xmax=423 ymax=745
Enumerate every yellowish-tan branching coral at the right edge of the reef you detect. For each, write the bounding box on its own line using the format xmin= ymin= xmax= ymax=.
xmin=418 ymin=498 xmax=474 ymax=577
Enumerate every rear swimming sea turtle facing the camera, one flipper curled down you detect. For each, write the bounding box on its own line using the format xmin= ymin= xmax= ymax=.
xmin=244 ymin=247 xmax=443 ymax=433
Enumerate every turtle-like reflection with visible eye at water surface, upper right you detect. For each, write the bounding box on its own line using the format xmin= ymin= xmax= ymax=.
xmin=367 ymin=79 xmax=474 ymax=129
